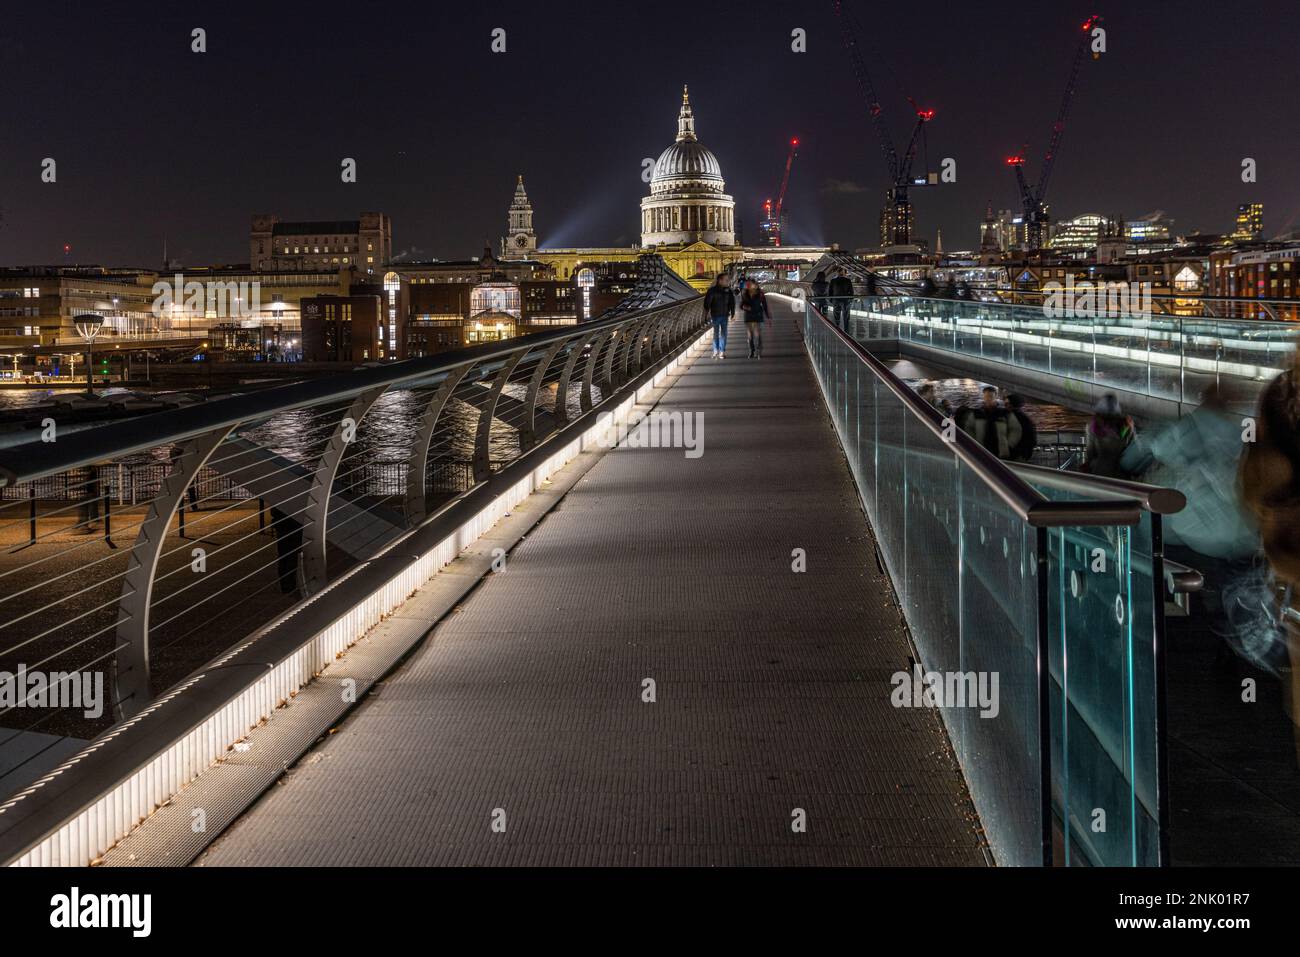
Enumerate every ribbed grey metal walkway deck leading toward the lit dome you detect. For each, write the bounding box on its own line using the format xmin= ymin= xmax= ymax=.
xmin=198 ymin=298 xmax=985 ymax=866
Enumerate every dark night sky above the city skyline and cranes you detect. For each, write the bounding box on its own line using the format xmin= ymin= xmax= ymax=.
xmin=0 ymin=0 xmax=1300 ymax=267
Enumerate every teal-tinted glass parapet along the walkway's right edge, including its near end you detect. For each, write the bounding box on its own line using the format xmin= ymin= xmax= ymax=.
xmin=803 ymin=303 xmax=1164 ymax=866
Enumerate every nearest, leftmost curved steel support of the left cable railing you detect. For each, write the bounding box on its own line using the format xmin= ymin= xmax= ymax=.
xmin=113 ymin=425 xmax=235 ymax=719
